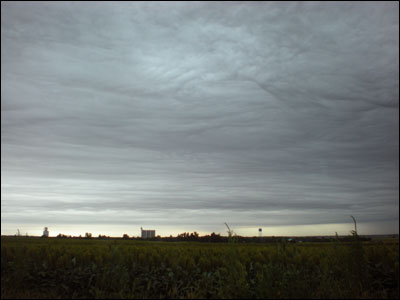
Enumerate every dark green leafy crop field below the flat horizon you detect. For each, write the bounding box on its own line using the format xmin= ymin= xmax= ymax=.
xmin=1 ymin=237 xmax=399 ymax=299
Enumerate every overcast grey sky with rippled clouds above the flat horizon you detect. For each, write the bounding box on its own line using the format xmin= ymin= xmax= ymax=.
xmin=1 ymin=1 xmax=399 ymax=236
